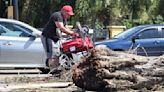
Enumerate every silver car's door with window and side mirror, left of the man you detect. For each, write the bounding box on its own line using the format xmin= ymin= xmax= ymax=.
xmin=0 ymin=23 xmax=44 ymax=67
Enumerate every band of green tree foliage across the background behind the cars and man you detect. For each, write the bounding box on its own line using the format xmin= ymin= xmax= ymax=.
xmin=0 ymin=0 xmax=164 ymax=28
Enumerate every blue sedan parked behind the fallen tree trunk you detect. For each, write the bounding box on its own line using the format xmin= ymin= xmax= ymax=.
xmin=95 ymin=24 xmax=164 ymax=56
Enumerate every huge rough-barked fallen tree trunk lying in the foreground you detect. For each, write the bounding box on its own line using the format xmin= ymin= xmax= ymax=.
xmin=73 ymin=46 xmax=164 ymax=92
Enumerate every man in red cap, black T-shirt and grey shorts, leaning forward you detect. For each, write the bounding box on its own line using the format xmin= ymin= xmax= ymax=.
xmin=41 ymin=5 xmax=78 ymax=70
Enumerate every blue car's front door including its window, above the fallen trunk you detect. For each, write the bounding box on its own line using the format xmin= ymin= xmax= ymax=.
xmin=134 ymin=27 xmax=161 ymax=56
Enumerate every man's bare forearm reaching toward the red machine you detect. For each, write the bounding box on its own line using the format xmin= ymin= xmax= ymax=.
xmin=55 ymin=22 xmax=74 ymax=35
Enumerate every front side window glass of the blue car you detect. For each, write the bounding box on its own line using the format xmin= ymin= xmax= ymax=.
xmin=137 ymin=28 xmax=160 ymax=39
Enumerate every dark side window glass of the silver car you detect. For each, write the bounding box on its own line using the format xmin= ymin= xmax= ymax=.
xmin=0 ymin=22 xmax=32 ymax=37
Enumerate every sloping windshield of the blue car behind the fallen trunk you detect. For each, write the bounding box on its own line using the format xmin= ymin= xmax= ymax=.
xmin=113 ymin=27 xmax=142 ymax=39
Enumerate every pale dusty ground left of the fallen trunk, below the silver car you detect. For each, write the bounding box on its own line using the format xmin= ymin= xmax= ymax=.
xmin=0 ymin=69 xmax=82 ymax=92
